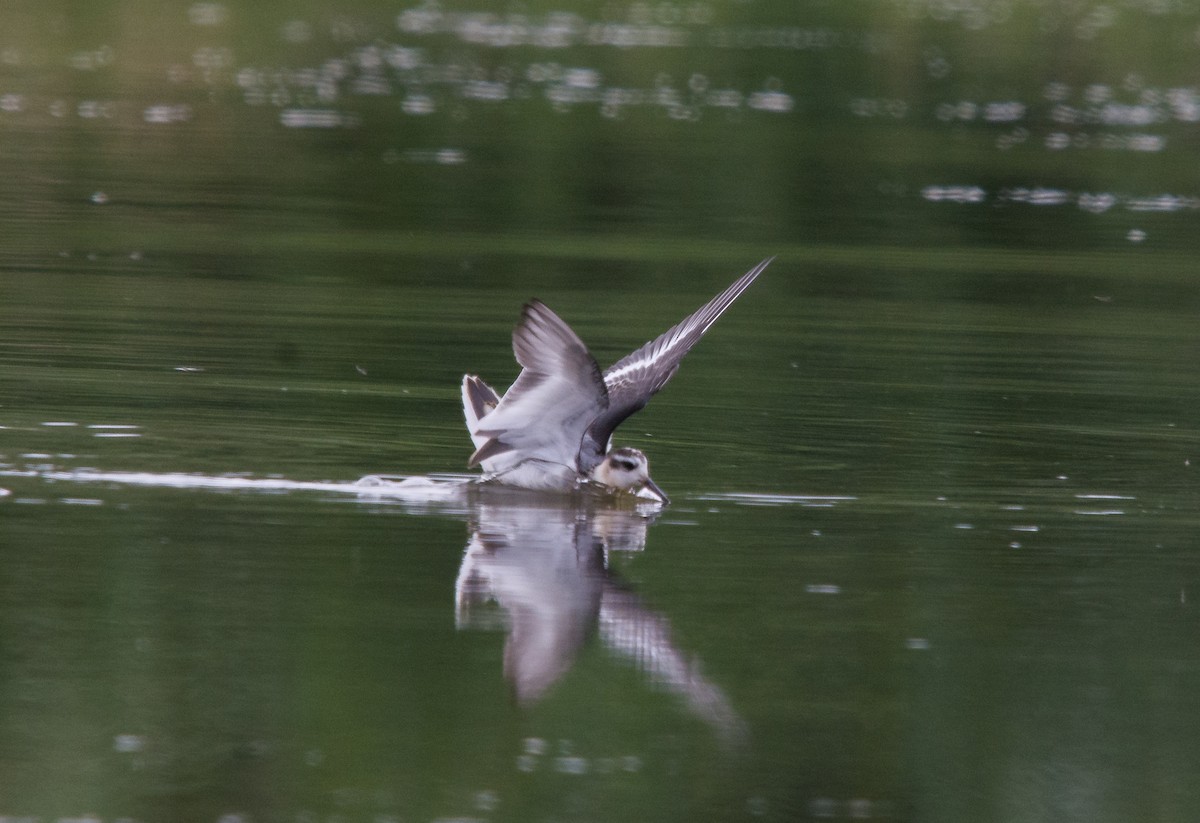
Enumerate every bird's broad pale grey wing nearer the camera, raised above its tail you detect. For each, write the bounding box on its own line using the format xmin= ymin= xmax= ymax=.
xmin=468 ymin=300 xmax=608 ymax=470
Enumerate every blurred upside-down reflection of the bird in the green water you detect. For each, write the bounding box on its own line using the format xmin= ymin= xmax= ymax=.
xmin=455 ymin=501 xmax=745 ymax=743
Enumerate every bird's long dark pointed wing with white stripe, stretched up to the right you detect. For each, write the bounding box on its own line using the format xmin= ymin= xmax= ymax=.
xmin=578 ymin=257 xmax=775 ymax=471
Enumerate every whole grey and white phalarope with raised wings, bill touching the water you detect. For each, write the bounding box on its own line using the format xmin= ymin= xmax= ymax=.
xmin=462 ymin=258 xmax=774 ymax=504
